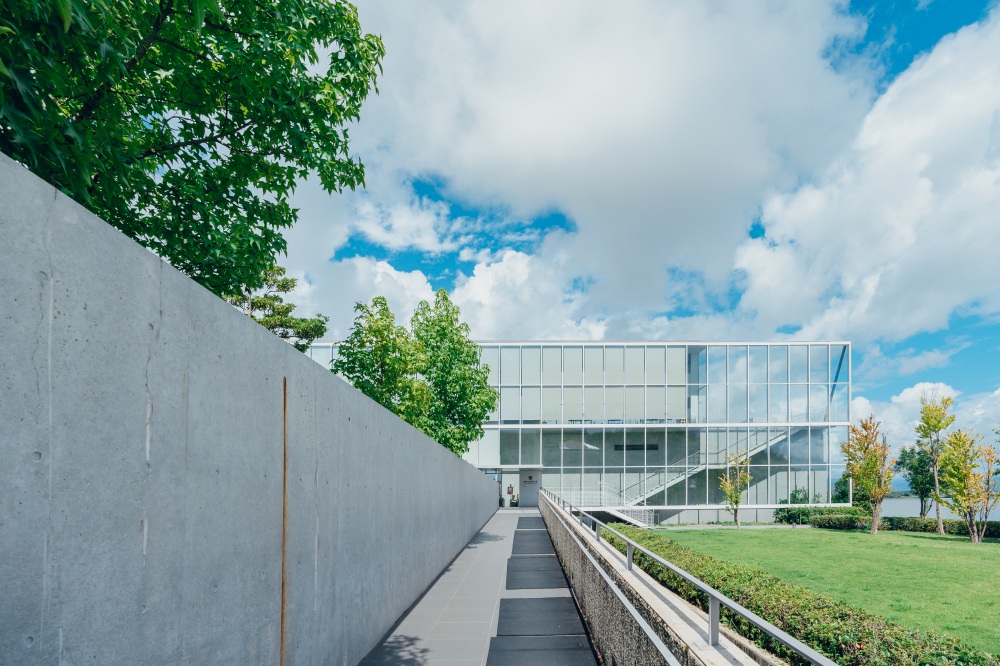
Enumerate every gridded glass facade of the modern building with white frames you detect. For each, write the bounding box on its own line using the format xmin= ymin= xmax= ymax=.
xmin=465 ymin=342 xmax=851 ymax=509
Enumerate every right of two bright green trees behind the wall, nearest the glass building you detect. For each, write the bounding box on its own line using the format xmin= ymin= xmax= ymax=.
xmin=410 ymin=289 xmax=499 ymax=455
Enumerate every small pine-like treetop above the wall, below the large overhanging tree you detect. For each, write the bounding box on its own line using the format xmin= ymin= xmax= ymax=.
xmin=226 ymin=266 xmax=330 ymax=352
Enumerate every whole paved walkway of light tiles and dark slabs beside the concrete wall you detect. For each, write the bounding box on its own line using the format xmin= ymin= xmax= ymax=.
xmin=361 ymin=509 xmax=597 ymax=666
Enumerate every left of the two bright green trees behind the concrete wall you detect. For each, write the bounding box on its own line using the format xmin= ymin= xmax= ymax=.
xmin=331 ymin=296 xmax=429 ymax=416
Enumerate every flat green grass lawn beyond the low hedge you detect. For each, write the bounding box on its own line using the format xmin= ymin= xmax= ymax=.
xmin=660 ymin=529 xmax=1000 ymax=655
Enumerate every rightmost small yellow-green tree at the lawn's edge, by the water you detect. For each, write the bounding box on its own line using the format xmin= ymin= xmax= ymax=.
xmin=935 ymin=430 xmax=1000 ymax=543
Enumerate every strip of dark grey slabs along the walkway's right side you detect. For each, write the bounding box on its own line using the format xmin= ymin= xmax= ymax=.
xmin=486 ymin=516 xmax=598 ymax=666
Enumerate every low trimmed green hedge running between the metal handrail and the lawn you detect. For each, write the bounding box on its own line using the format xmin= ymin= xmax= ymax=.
xmin=604 ymin=524 xmax=1000 ymax=666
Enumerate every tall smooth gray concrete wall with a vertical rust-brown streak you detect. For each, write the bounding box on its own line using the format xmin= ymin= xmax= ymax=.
xmin=0 ymin=155 xmax=497 ymax=664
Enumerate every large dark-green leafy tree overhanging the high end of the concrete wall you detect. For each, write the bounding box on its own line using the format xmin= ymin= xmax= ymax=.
xmin=0 ymin=0 xmax=384 ymax=295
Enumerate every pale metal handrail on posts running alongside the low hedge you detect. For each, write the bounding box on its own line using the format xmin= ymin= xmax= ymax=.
xmin=539 ymin=488 xmax=837 ymax=666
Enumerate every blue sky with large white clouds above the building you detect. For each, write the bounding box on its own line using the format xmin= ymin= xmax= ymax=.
xmin=286 ymin=0 xmax=1000 ymax=441
